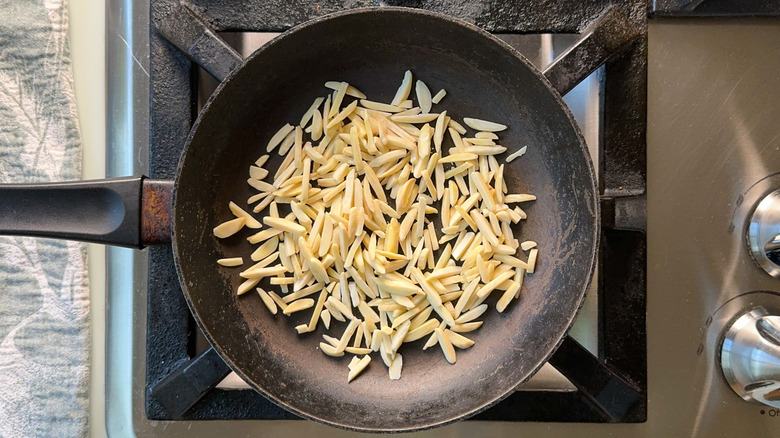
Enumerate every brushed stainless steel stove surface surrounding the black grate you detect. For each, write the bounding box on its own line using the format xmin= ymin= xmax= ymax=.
xmin=106 ymin=2 xmax=780 ymax=437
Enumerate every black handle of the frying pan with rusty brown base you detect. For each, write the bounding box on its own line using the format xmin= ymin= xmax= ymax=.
xmin=0 ymin=176 xmax=173 ymax=248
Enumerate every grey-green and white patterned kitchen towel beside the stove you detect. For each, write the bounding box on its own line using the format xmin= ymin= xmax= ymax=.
xmin=0 ymin=0 xmax=90 ymax=438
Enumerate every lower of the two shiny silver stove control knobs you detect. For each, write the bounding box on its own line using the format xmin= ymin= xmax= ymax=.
xmin=720 ymin=307 xmax=780 ymax=408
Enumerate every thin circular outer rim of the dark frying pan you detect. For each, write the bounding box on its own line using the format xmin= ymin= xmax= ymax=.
xmin=171 ymin=6 xmax=601 ymax=433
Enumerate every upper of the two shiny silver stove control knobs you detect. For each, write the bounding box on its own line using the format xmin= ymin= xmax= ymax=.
xmin=748 ymin=190 xmax=780 ymax=278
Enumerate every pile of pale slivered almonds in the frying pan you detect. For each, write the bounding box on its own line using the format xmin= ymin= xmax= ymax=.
xmin=214 ymin=71 xmax=538 ymax=381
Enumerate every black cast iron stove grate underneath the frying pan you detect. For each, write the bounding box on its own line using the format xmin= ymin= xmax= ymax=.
xmin=146 ymin=0 xmax=647 ymax=422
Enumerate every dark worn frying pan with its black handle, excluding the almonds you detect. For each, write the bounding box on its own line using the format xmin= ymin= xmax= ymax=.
xmin=0 ymin=8 xmax=599 ymax=431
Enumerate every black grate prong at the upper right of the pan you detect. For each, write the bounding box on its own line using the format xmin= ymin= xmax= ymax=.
xmin=542 ymin=7 xmax=642 ymax=96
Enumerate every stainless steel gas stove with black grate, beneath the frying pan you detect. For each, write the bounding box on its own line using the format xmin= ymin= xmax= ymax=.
xmin=106 ymin=0 xmax=780 ymax=436
